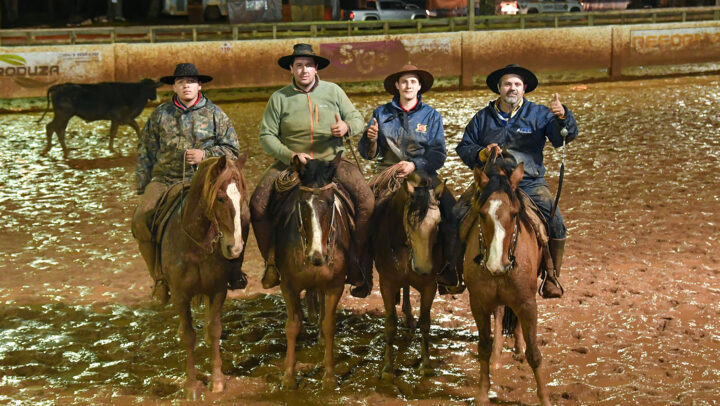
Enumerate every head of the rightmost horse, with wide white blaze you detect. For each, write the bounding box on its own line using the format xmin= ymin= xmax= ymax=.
xmin=472 ymin=152 xmax=524 ymax=275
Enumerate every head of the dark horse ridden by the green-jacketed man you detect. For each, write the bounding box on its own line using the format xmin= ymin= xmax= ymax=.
xmin=293 ymin=151 xmax=342 ymax=266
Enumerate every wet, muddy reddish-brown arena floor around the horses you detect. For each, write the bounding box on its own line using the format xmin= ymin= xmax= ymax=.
xmin=0 ymin=76 xmax=720 ymax=405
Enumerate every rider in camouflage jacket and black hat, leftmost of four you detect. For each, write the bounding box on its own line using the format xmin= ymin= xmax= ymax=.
xmin=132 ymin=63 xmax=241 ymax=304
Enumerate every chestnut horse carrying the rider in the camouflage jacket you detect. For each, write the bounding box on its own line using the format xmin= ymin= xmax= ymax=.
xmin=160 ymin=154 xmax=250 ymax=399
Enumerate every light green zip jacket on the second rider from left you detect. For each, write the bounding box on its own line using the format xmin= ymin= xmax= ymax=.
xmin=260 ymin=77 xmax=365 ymax=164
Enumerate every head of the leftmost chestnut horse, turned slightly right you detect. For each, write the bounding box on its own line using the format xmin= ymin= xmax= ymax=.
xmin=193 ymin=153 xmax=250 ymax=259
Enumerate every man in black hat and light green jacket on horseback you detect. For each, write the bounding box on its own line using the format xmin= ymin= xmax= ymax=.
xmin=250 ymin=44 xmax=375 ymax=297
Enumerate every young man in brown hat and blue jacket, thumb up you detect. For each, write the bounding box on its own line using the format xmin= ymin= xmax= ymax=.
xmin=358 ymin=65 xmax=460 ymax=293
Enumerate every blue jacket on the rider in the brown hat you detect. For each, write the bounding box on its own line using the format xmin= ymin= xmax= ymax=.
xmin=358 ymin=95 xmax=447 ymax=176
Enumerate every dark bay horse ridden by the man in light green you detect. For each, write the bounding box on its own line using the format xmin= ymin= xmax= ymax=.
xmin=269 ymin=152 xmax=352 ymax=389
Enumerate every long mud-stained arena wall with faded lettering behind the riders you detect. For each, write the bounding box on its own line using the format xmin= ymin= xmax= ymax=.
xmin=0 ymin=22 xmax=720 ymax=99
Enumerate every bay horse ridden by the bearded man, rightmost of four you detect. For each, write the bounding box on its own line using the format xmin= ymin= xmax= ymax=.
xmin=461 ymin=152 xmax=550 ymax=405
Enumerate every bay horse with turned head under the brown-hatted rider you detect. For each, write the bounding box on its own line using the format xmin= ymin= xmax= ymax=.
xmin=373 ymin=172 xmax=445 ymax=379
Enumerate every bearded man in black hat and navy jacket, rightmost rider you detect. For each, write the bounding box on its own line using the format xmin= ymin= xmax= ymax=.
xmin=455 ymin=64 xmax=578 ymax=297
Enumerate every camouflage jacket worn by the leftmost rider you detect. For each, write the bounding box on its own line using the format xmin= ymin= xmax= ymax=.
xmin=136 ymin=96 xmax=240 ymax=194
